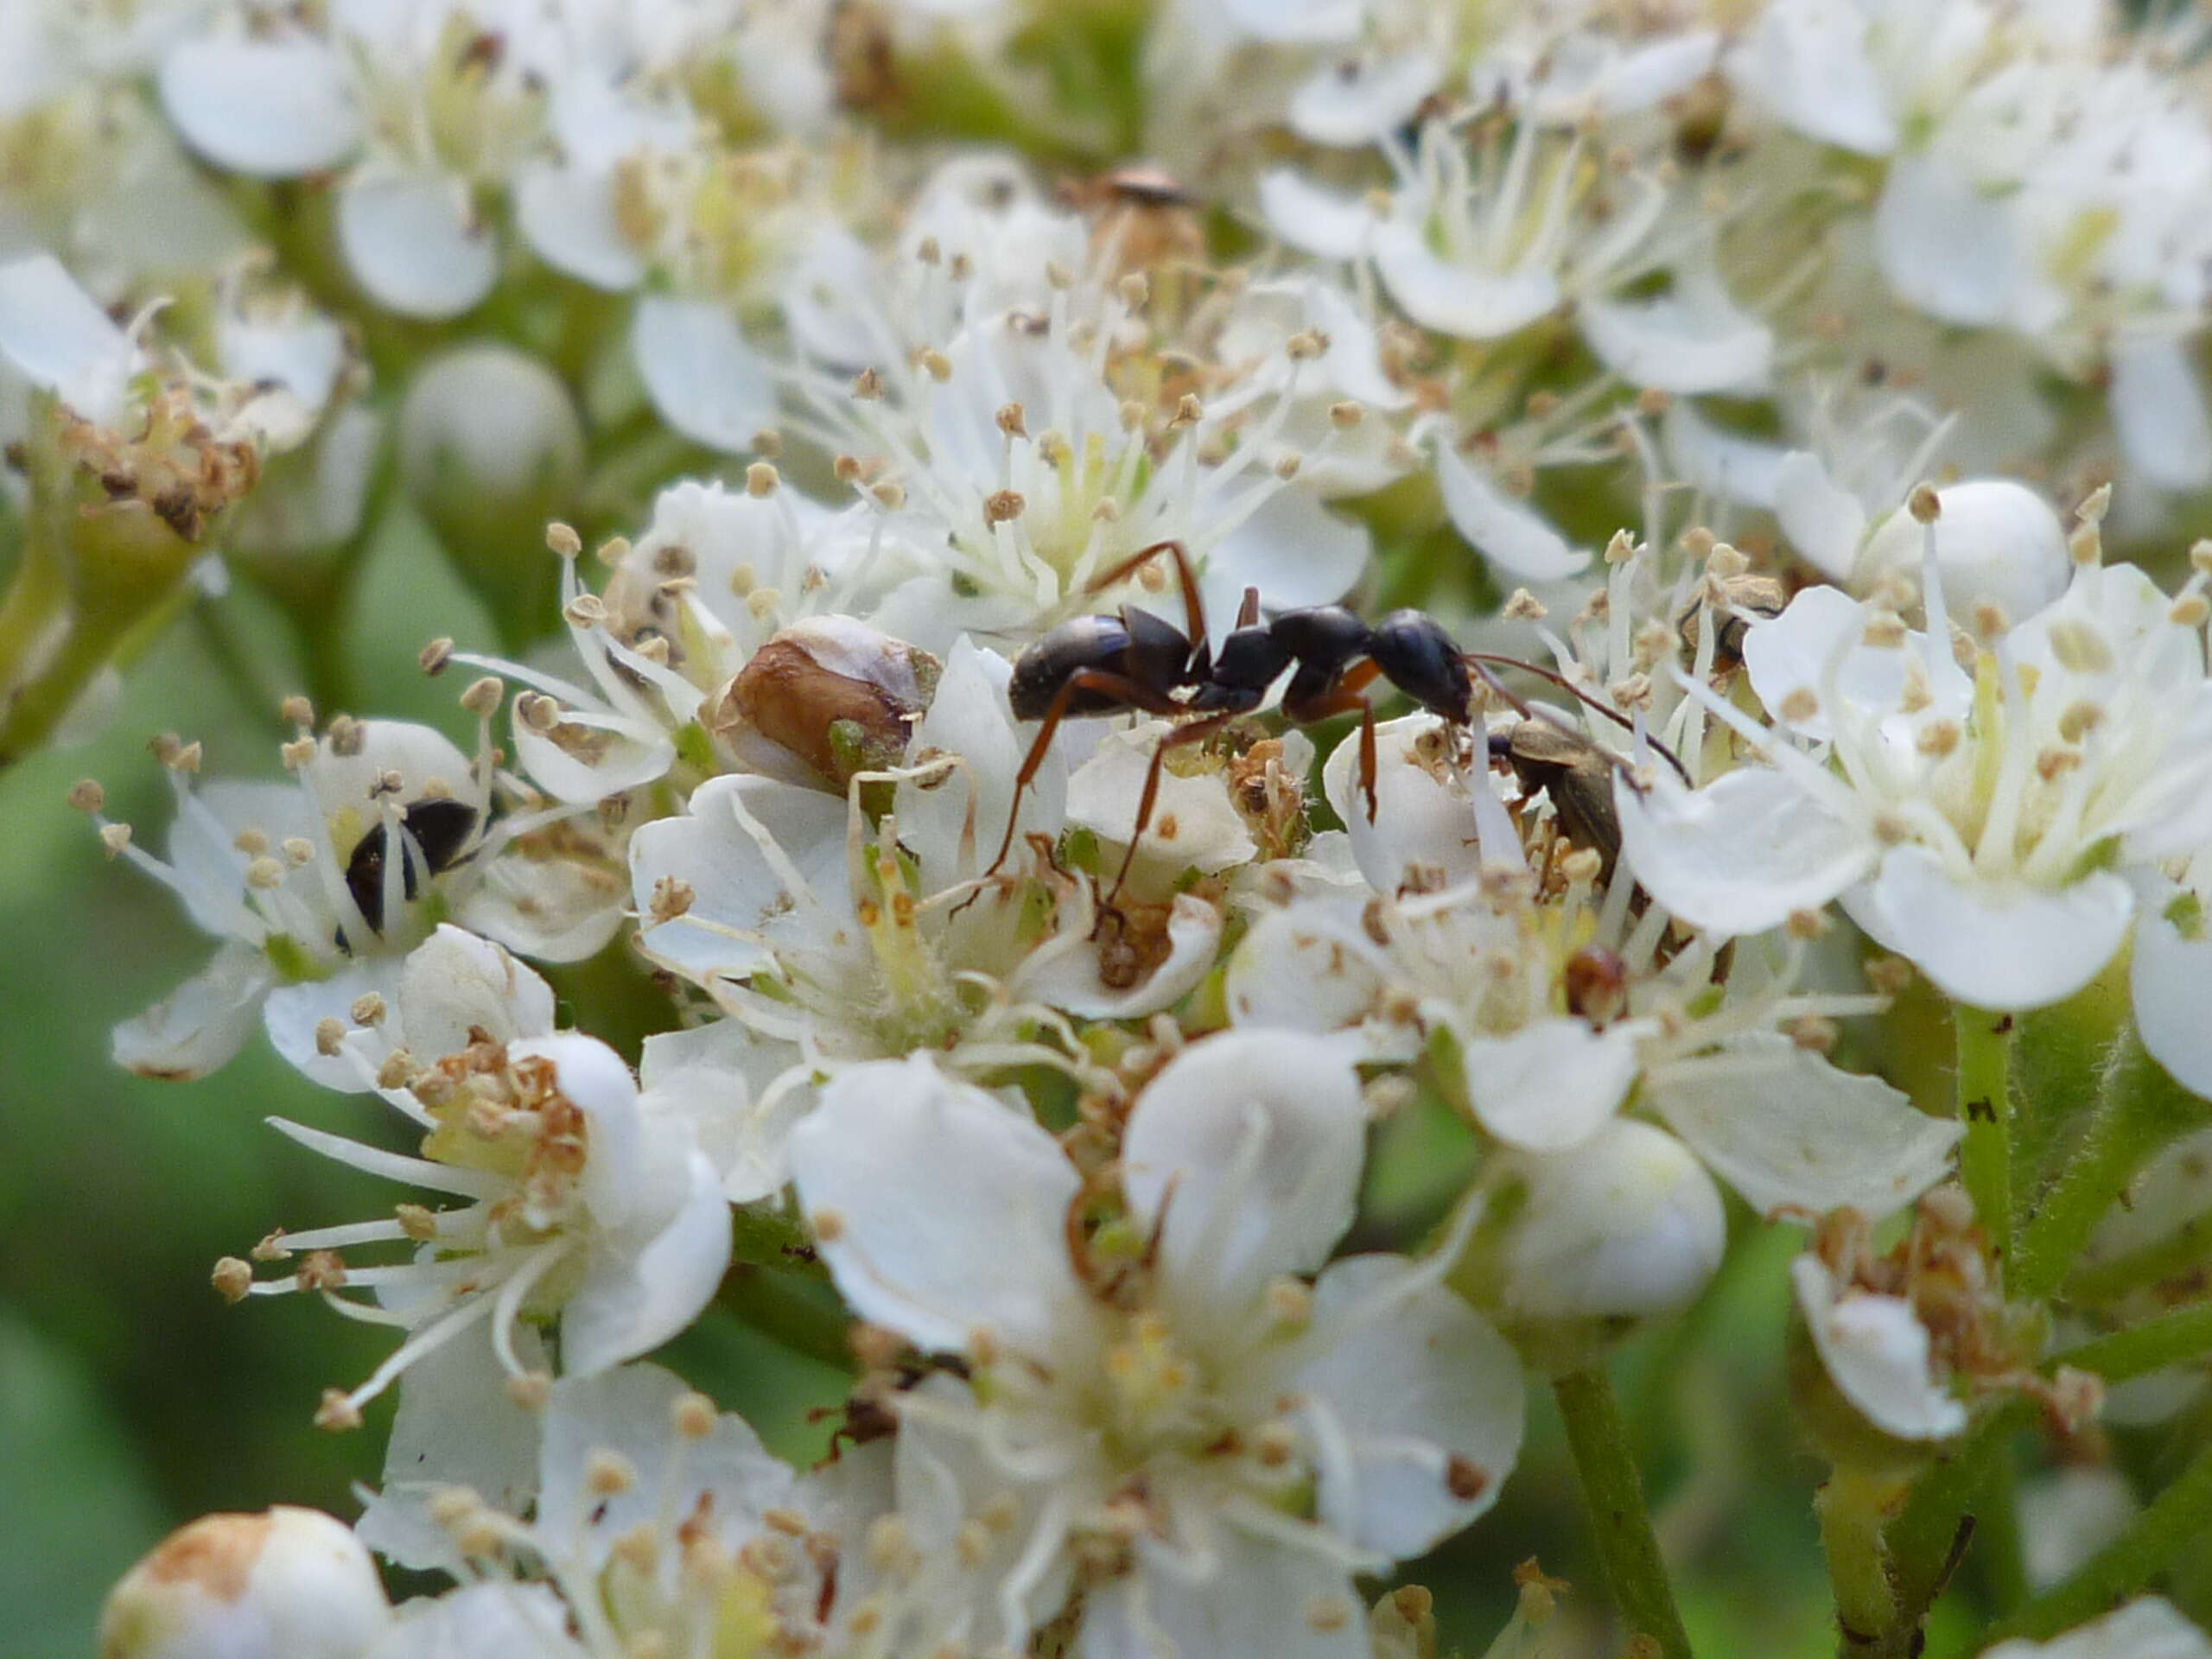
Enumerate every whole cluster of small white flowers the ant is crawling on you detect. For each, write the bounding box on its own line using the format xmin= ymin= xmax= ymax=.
xmin=0 ymin=0 xmax=2212 ymax=1659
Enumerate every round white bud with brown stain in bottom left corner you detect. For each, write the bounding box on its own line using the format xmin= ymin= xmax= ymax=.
xmin=99 ymin=1504 xmax=391 ymax=1659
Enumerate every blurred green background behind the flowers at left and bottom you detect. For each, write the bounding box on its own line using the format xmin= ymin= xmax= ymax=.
xmin=0 ymin=518 xmax=1991 ymax=1659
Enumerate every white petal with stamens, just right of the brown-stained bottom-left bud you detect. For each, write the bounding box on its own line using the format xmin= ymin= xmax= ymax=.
xmin=537 ymin=1365 xmax=791 ymax=1571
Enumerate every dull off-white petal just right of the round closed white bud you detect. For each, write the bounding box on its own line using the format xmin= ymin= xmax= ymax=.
xmin=1646 ymin=1033 xmax=1962 ymax=1221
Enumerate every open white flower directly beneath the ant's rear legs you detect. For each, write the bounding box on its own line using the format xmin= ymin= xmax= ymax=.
xmin=631 ymin=639 xmax=1224 ymax=1201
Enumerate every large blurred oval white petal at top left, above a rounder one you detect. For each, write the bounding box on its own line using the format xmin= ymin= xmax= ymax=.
xmin=162 ymin=35 xmax=360 ymax=179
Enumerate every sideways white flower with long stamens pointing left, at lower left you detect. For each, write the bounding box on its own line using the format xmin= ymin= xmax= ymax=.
xmin=250 ymin=946 xmax=730 ymax=1425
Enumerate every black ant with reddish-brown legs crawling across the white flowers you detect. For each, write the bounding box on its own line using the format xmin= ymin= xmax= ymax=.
xmin=984 ymin=542 xmax=1688 ymax=905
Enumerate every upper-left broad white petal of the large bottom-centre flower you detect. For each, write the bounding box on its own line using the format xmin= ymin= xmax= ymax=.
xmin=790 ymin=1055 xmax=1084 ymax=1356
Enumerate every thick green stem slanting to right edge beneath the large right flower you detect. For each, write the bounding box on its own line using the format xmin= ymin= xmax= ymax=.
xmin=2013 ymin=1027 xmax=2205 ymax=1300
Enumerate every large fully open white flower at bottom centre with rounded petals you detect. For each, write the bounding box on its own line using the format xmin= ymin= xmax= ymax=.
xmin=791 ymin=1033 xmax=1522 ymax=1655
